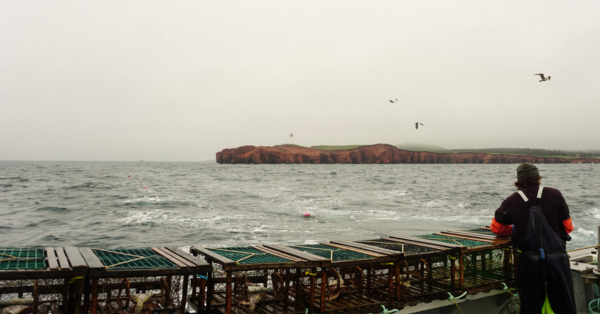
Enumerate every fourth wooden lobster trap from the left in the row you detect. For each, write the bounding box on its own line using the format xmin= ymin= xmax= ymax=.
xmin=288 ymin=241 xmax=404 ymax=313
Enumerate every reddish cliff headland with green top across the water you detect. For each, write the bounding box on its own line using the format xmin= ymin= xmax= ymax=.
xmin=217 ymin=144 xmax=600 ymax=164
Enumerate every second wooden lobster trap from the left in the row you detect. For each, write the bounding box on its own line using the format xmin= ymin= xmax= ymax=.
xmin=79 ymin=247 xmax=210 ymax=314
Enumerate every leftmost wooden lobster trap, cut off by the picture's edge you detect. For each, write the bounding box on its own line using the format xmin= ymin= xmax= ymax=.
xmin=0 ymin=247 xmax=88 ymax=314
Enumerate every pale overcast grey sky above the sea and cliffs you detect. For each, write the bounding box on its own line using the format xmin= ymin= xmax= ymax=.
xmin=0 ymin=0 xmax=600 ymax=161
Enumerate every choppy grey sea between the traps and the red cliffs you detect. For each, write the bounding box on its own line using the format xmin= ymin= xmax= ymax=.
xmin=0 ymin=161 xmax=600 ymax=248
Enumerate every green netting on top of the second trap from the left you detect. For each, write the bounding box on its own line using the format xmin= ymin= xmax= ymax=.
xmin=92 ymin=248 xmax=177 ymax=270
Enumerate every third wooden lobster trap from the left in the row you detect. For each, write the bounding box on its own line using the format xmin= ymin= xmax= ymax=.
xmin=190 ymin=245 xmax=325 ymax=314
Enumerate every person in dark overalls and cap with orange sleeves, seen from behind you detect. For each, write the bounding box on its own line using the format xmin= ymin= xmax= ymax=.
xmin=491 ymin=162 xmax=576 ymax=314
